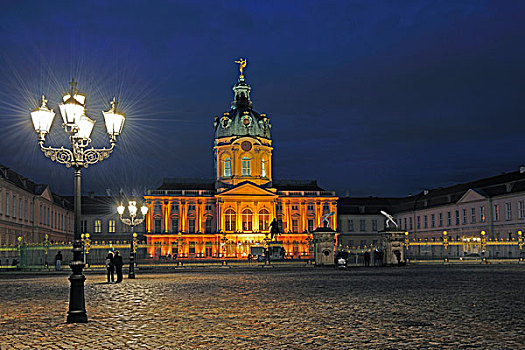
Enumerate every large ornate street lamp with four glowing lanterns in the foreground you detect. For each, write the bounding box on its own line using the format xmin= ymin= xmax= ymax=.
xmin=31 ymin=79 xmax=126 ymax=323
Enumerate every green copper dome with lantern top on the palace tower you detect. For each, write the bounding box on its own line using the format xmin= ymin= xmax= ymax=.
xmin=214 ymin=76 xmax=271 ymax=139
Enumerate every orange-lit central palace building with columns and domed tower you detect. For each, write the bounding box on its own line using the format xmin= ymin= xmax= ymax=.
xmin=145 ymin=65 xmax=337 ymax=259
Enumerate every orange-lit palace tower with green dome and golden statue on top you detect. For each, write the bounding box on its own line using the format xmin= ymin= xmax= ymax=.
xmin=214 ymin=59 xmax=273 ymax=189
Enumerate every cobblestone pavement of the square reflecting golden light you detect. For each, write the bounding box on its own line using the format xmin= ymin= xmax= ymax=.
xmin=0 ymin=265 xmax=525 ymax=350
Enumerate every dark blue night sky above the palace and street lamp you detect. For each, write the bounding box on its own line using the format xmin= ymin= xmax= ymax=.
xmin=0 ymin=0 xmax=525 ymax=196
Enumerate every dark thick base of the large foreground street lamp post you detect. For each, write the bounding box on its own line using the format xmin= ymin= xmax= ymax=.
xmin=67 ymin=240 xmax=87 ymax=323
